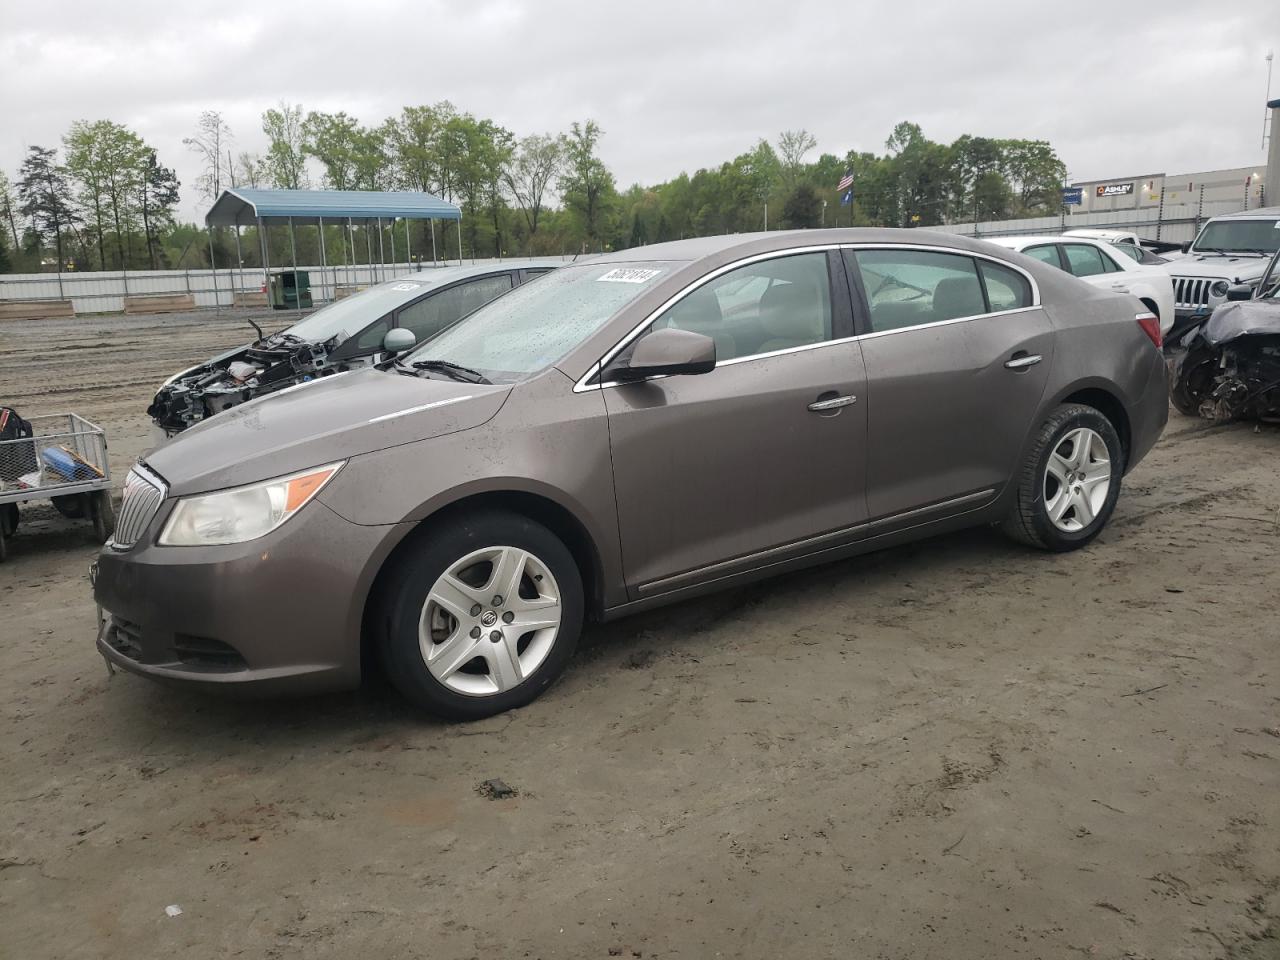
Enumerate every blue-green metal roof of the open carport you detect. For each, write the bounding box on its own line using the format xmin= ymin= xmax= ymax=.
xmin=205 ymin=187 xmax=462 ymax=227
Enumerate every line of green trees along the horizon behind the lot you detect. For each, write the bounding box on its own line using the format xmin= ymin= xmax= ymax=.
xmin=0 ymin=101 xmax=1066 ymax=271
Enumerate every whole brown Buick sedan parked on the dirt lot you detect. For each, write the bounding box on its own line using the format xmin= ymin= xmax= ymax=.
xmin=95 ymin=229 xmax=1167 ymax=718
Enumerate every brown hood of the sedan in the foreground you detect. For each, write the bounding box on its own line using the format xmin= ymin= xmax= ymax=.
xmin=143 ymin=370 xmax=511 ymax=495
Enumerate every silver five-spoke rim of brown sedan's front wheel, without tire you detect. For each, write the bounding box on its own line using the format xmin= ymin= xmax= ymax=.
xmin=419 ymin=547 xmax=562 ymax=696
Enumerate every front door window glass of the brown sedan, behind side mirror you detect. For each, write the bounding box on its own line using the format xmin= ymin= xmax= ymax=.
xmin=649 ymin=252 xmax=832 ymax=361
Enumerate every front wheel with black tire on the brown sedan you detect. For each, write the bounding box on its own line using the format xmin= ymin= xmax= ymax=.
xmin=378 ymin=511 xmax=584 ymax=719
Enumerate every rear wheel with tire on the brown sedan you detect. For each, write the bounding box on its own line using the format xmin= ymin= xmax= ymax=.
xmin=1001 ymin=403 xmax=1124 ymax=552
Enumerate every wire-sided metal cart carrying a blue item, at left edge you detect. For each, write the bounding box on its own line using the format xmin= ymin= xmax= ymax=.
xmin=0 ymin=413 xmax=115 ymax=562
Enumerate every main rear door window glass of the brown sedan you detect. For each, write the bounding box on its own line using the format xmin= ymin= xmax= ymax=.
xmin=852 ymin=250 xmax=989 ymax=333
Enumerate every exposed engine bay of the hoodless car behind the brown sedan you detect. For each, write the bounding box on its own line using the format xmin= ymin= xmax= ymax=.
xmin=147 ymin=333 xmax=381 ymax=436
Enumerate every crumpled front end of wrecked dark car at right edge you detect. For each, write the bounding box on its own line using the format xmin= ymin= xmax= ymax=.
xmin=1169 ymin=297 xmax=1280 ymax=422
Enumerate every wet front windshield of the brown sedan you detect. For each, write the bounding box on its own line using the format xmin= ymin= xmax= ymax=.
xmin=403 ymin=261 xmax=680 ymax=383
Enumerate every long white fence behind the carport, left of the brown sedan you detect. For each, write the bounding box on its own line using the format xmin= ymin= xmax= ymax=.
xmin=0 ymin=257 xmax=562 ymax=314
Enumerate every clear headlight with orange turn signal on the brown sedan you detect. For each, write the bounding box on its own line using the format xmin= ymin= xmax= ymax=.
xmin=159 ymin=461 xmax=346 ymax=547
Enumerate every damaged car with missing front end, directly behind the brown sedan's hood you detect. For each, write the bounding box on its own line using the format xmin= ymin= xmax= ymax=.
xmin=147 ymin=260 xmax=558 ymax=436
